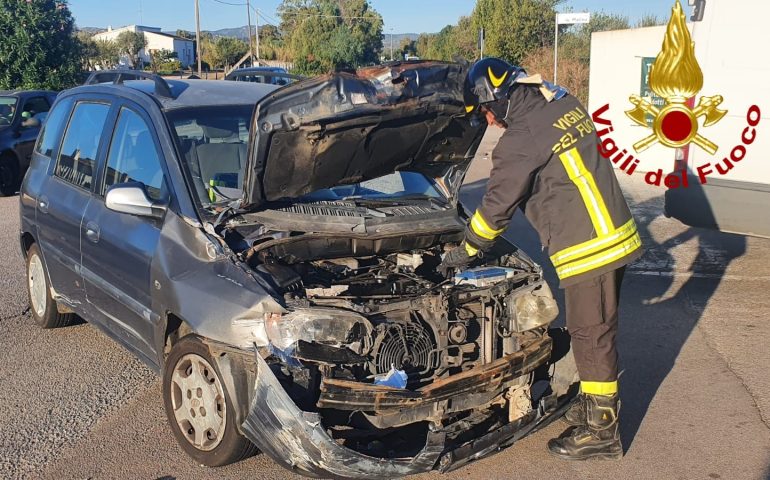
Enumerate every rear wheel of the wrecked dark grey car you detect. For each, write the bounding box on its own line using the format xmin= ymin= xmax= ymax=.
xmin=27 ymin=243 xmax=76 ymax=328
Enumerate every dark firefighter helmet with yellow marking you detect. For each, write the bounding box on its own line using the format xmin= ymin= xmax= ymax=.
xmin=463 ymin=58 xmax=524 ymax=113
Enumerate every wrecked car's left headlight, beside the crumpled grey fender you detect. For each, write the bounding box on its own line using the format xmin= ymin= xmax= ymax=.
xmin=265 ymin=308 xmax=372 ymax=355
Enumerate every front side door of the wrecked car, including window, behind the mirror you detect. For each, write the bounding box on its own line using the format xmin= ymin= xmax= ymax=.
xmin=81 ymin=103 xmax=169 ymax=362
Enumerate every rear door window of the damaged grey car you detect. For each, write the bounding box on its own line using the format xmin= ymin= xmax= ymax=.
xmin=54 ymin=102 xmax=110 ymax=190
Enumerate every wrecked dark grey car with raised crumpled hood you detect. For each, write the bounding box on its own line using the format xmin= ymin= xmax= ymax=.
xmin=21 ymin=62 xmax=577 ymax=478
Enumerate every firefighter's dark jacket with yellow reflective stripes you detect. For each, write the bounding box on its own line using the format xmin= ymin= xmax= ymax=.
xmin=466 ymin=82 xmax=642 ymax=288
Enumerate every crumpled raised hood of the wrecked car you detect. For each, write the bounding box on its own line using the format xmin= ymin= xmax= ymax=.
xmin=242 ymin=61 xmax=485 ymax=208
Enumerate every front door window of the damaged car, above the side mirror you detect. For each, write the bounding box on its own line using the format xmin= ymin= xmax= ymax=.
xmin=104 ymin=107 xmax=165 ymax=200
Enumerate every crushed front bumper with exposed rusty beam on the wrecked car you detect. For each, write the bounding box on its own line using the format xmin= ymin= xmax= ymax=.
xmin=241 ymin=332 xmax=575 ymax=479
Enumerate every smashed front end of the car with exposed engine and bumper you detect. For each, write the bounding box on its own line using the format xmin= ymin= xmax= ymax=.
xmin=218 ymin=217 xmax=577 ymax=478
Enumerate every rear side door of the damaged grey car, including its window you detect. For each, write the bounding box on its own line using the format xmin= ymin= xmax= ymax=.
xmin=34 ymin=98 xmax=110 ymax=306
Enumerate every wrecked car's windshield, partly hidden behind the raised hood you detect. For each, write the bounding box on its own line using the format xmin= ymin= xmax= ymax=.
xmin=168 ymin=105 xmax=444 ymax=209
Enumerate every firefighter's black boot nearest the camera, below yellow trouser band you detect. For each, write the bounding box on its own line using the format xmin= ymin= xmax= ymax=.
xmin=548 ymin=394 xmax=623 ymax=460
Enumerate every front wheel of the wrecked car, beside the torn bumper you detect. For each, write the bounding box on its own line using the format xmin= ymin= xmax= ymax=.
xmin=163 ymin=335 xmax=257 ymax=467
